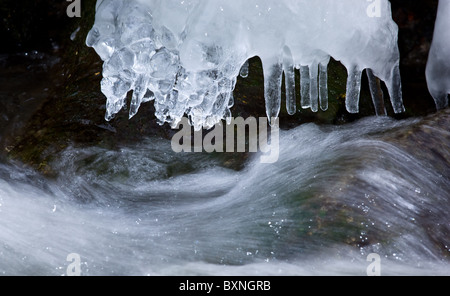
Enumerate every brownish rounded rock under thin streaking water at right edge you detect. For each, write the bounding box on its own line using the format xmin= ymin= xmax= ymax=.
xmin=308 ymin=109 xmax=450 ymax=258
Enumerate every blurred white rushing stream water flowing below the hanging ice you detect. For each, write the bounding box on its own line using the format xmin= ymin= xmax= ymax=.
xmin=0 ymin=118 xmax=450 ymax=275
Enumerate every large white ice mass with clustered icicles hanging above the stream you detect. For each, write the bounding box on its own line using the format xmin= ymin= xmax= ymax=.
xmin=86 ymin=0 xmax=404 ymax=129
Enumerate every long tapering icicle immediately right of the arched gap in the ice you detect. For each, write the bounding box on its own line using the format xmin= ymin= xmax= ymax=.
xmin=264 ymin=62 xmax=283 ymax=125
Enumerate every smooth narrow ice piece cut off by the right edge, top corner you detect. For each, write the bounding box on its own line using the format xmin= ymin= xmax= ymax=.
xmin=426 ymin=0 xmax=450 ymax=109
